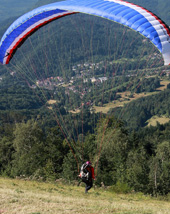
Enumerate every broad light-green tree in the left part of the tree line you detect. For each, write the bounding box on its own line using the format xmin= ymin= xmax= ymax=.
xmin=12 ymin=120 xmax=46 ymax=176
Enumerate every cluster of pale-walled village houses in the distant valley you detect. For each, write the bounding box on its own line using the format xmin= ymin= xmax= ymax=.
xmin=31 ymin=55 xmax=170 ymax=90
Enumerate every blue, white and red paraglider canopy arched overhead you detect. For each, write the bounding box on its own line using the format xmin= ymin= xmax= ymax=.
xmin=0 ymin=0 xmax=170 ymax=65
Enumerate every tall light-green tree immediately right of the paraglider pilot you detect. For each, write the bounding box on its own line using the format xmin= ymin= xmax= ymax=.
xmin=96 ymin=118 xmax=130 ymax=185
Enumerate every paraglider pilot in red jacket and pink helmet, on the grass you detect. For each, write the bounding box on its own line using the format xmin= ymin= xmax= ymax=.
xmin=79 ymin=161 xmax=95 ymax=193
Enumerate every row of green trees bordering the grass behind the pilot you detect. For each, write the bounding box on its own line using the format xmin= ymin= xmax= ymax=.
xmin=0 ymin=115 xmax=170 ymax=196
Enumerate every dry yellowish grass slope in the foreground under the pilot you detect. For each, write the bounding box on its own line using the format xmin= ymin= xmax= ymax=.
xmin=0 ymin=178 xmax=170 ymax=214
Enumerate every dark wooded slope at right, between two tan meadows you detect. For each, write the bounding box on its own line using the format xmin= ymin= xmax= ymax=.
xmin=114 ymin=84 xmax=170 ymax=129
